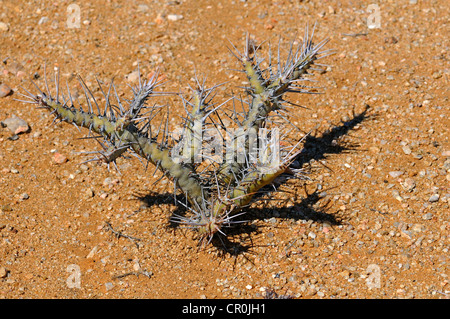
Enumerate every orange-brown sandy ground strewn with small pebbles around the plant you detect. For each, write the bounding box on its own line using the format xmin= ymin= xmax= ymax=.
xmin=0 ymin=0 xmax=450 ymax=299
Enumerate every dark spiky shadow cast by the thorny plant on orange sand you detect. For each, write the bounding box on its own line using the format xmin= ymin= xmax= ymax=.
xmin=135 ymin=105 xmax=375 ymax=256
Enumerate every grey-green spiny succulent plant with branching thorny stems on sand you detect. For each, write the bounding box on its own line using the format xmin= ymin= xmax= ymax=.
xmin=17 ymin=27 xmax=331 ymax=248
